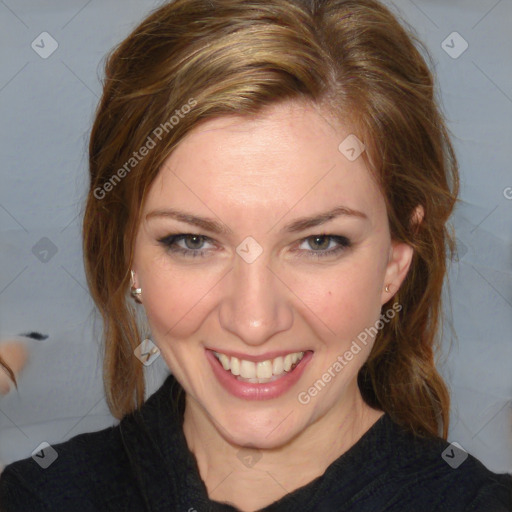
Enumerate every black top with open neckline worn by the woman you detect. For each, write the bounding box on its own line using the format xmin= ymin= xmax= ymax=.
xmin=0 ymin=376 xmax=512 ymax=512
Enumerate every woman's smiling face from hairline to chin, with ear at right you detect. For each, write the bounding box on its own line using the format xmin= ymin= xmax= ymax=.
xmin=133 ymin=103 xmax=412 ymax=448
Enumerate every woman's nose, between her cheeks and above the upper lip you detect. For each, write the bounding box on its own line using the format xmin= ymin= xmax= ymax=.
xmin=219 ymin=255 xmax=293 ymax=346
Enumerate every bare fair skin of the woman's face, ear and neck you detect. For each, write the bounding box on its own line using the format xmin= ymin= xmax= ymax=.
xmin=133 ymin=102 xmax=412 ymax=511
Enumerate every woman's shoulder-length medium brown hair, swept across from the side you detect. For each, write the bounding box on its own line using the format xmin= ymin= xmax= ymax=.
xmin=83 ymin=0 xmax=458 ymax=438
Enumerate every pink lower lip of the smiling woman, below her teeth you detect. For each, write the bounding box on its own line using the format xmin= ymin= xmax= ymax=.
xmin=206 ymin=349 xmax=313 ymax=400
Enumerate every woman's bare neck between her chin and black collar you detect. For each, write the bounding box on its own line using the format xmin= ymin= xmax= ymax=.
xmin=183 ymin=383 xmax=384 ymax=512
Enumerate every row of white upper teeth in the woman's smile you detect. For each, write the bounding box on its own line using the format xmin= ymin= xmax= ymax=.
xmin=214 ymin=352 xmax=304 ymax=379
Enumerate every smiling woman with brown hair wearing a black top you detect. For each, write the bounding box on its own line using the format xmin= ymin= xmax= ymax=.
xmin=0 ymin=0 xmax=512 ymax=512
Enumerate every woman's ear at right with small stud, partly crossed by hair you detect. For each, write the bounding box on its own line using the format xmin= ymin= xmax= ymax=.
xmin=381 ymin=205 xmax=425 ymax=304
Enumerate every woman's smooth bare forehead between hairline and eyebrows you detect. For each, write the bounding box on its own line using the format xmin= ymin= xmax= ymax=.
xmin=144 ymin=102 xmax=383 ymax=224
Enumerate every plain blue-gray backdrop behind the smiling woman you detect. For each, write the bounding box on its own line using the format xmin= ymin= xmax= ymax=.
xmin=0 ymin=0 xmax=512 ymax=471
